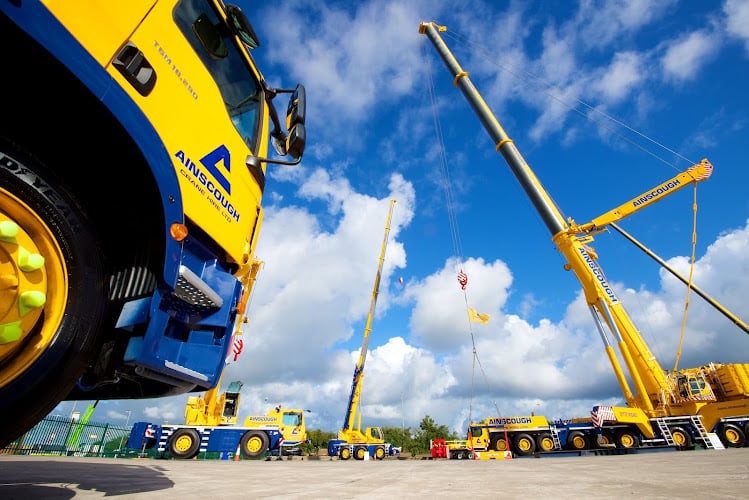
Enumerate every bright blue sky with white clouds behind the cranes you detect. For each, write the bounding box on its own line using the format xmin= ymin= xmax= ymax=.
xmin=54 ymin=0 xmax=749 ymax=434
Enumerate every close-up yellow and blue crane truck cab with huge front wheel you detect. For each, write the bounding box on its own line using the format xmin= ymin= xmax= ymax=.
xmin=0 ymin=0 xmax=305 ymax=447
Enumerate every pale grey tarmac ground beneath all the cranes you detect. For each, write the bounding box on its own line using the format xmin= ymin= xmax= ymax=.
xmin=0 ymin=448 xmax=749 ymax=500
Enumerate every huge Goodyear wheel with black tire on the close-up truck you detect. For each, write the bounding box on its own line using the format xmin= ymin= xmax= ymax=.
xmin=0 ymin=137 xmax=106 ymax=448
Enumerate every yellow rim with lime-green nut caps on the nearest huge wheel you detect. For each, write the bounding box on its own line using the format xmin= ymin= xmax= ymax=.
xmin=0 ymin=189 xmax=68 ymax=387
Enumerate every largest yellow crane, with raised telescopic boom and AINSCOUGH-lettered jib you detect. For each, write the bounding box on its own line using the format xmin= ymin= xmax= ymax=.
xmin=419 ymin=23 xmax=749 ymax=449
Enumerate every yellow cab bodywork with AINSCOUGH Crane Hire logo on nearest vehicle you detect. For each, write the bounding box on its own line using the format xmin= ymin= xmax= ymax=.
xmin=46 ymin=0 xmax=268 ymax=266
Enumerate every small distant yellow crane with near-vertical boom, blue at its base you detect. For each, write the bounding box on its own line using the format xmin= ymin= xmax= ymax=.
xmin=328 ymin=200 xmax=396 ymax=460
